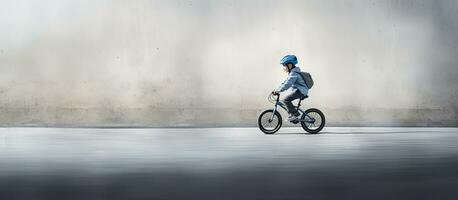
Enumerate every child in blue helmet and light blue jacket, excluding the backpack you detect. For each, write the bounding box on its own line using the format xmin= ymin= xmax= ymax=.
xmin=272 ymin=55 xmax=309 ymax=121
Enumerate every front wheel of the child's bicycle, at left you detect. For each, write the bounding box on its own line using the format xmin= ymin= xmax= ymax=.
xmin=258 ymin=109 xmax=282 ymax=134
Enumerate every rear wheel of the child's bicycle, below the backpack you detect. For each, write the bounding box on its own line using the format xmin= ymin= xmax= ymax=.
xmin=301 ymin=108 xmax=326 ymax=134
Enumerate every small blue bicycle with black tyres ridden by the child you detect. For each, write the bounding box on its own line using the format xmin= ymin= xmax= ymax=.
xmin=258 ymin=93 xmax=326 ymax=134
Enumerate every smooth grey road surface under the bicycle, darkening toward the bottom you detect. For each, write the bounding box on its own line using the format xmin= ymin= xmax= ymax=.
xmin=0 ymin=128 xmax=458 ymax=200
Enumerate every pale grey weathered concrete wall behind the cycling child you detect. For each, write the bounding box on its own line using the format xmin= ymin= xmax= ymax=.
xmin=0 ymin=0 xmax=458 ymax=126
